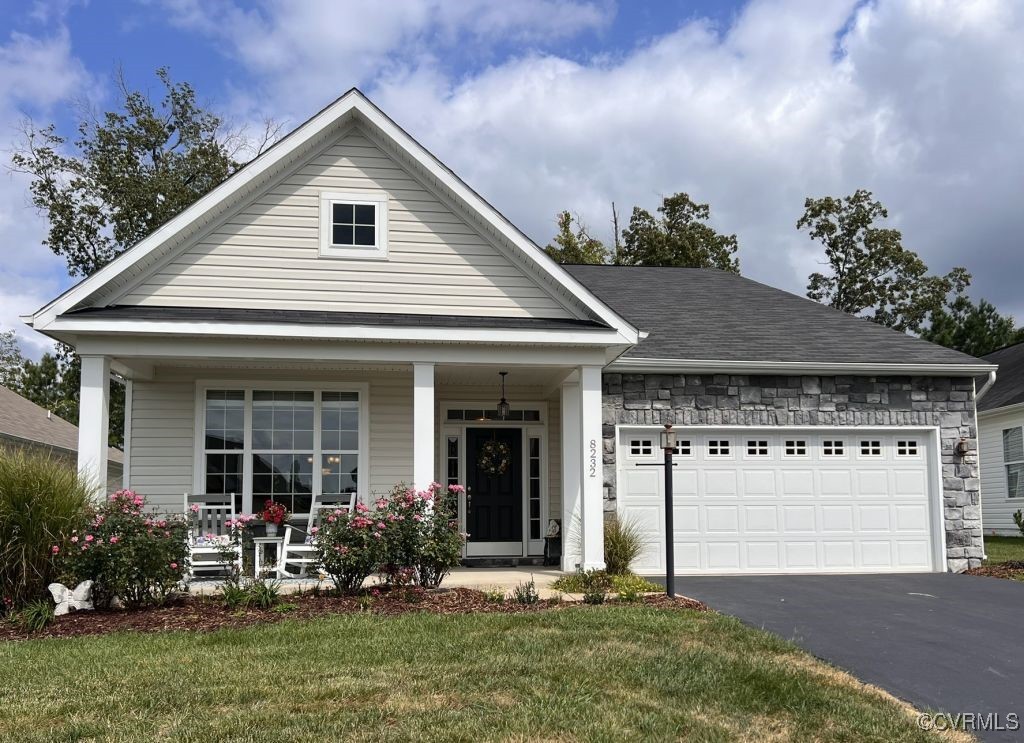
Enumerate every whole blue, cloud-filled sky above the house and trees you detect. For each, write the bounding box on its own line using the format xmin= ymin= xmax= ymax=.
xmin=0 ymin=0 xmax=1024 ymax=355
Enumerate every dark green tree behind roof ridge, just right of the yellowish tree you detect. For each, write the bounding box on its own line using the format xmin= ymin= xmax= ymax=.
xmin=615 ymin=193 xmax=739 ymax=273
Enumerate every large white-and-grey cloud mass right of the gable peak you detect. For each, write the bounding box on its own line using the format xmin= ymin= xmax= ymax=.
xmin=161 ymin=0 xmax=1024 ymax=320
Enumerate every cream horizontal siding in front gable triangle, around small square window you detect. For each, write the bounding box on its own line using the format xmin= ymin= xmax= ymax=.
xmin=115 ymin=129 xmax=572 ymax=317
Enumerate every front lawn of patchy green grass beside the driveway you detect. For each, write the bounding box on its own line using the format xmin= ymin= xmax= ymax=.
xmin=0 ymin=606 xmax=942 ymax=742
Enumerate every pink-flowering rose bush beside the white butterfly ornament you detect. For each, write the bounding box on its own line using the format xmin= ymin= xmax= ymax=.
xmin=58 ymin=490 xmax=188 ymax=607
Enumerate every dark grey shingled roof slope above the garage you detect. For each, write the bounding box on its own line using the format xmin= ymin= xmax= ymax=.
xmin=565 ymin=265 xmax=992 ymax=374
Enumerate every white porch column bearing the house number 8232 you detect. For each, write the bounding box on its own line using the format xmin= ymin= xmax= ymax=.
xmin=580 ymin=365 xmax=604 ymax=570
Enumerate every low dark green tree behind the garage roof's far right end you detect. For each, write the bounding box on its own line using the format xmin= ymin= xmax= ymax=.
xmin=921 ymin=295 xmax=1024 ymax=356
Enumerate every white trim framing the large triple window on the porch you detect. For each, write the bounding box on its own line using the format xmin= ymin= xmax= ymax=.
xmin=193 ymin=380 xmax=370 ymax=517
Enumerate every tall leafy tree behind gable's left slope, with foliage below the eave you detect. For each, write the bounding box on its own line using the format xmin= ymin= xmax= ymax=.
xmin=11 ymin=68 xmax=266 ymax=445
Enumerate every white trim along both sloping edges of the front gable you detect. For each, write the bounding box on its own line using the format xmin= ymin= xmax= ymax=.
xmin=23 ymin=88 xmax=637 ymax=343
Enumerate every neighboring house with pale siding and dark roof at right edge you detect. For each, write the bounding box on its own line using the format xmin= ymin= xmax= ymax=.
xmin=978 ymin=343 xmax=1024 ymax=536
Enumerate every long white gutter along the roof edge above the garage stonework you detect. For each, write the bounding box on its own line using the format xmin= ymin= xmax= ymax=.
xmin=605 ymin=358 xmax=997 ymax=374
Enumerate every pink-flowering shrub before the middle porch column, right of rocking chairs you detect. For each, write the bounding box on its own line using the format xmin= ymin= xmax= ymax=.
xmin=313 ymin=483 xmax=465 ymax=592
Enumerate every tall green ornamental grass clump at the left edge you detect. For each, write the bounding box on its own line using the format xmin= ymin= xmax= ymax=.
xmin=0 ymin=451 xmax=92 ymax=614
